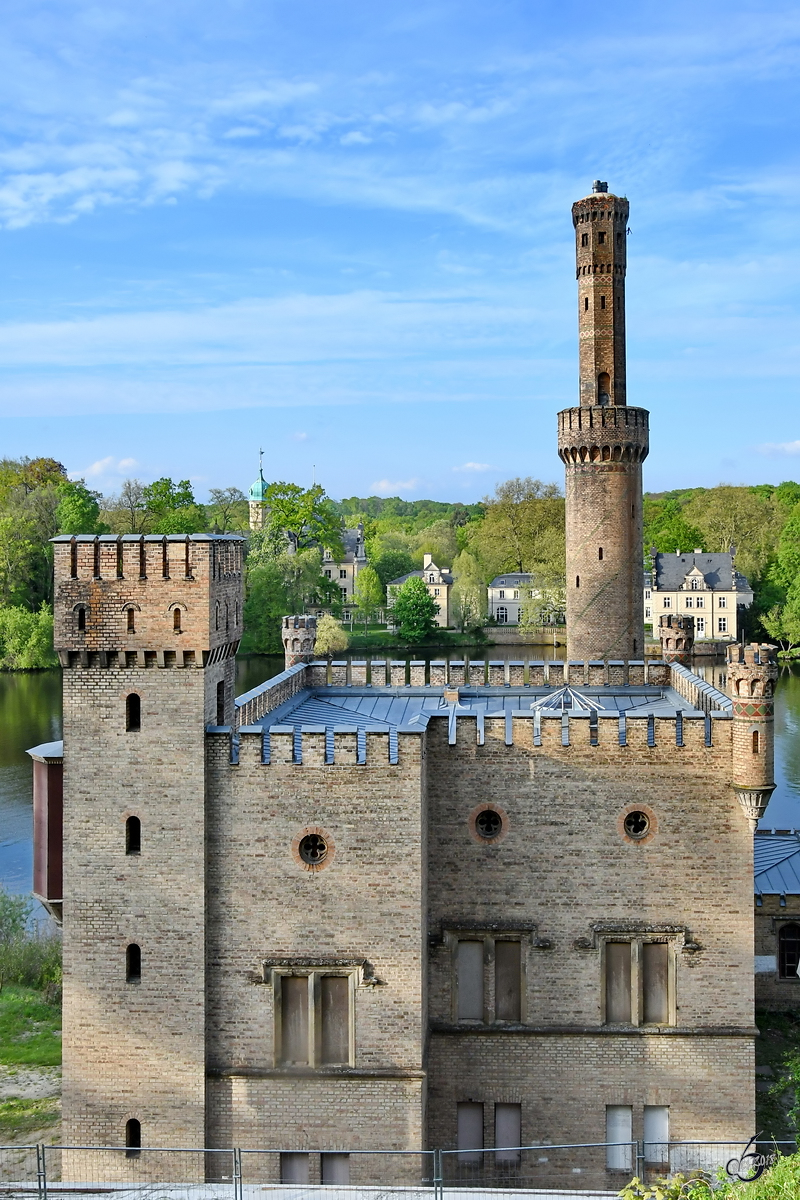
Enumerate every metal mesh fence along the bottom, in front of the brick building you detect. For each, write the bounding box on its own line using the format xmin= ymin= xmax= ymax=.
xmin=0 ymin=1139 xmax=796 ymax=1200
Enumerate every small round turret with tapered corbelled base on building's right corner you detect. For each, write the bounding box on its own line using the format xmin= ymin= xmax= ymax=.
xmin=728 ymin=643 xmax=777 ymax=830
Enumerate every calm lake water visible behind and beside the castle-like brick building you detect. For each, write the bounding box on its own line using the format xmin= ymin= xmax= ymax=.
xmin=0 ymin=646 xmax=800 ymax=892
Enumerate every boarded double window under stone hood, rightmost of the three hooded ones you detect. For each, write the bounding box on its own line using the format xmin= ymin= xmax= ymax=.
xmin=603 ymin=937 xmax=674 ymax=1025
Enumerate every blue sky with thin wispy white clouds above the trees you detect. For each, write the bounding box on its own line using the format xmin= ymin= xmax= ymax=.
xmin=0 ymin=0 xmax=800 ymax=502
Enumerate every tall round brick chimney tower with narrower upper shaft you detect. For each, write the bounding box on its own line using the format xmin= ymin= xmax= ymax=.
xmin=559 ymin=180 xmax=649 ymax=661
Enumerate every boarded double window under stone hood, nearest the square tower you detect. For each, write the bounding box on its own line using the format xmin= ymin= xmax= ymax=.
xmin=273 ymin=971 xmax=353 ymax=1067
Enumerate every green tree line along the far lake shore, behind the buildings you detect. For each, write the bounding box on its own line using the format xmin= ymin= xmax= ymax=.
xmin=0 ymin=457 xmax=800 ymax=668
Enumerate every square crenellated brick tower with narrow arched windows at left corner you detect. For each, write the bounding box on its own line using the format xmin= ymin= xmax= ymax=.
xmin=54 ymin=534 xmax=242 ymax=1161
